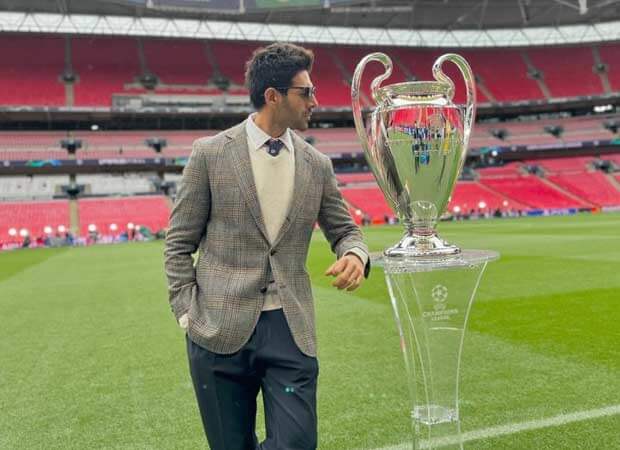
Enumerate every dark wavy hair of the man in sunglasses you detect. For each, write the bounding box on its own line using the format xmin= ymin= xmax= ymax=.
xmin=245 ymin=42 xmax=314 ymax=110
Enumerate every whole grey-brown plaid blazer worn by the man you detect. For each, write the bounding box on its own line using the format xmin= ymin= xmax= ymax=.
xmin=164 ymin=122 xmax=370 ymax=356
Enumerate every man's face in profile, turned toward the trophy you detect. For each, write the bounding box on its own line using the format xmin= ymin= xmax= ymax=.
xmin=277 ymin=70 xmax=319 ymax=131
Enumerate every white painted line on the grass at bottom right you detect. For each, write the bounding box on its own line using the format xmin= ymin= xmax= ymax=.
xmin=376 ymin=404 xmax=620 ymax=450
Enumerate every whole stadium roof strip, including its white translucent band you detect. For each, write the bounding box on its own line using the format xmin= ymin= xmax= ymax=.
xmin=0 ymin=0 xmax=620 ymax=47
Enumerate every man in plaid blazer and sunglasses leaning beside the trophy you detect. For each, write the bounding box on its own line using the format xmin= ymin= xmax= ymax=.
xmin=165 ymin=44 xmax=370 ymax=450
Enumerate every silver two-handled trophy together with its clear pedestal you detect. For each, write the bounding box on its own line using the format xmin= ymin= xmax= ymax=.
xmin=351 ymin=53 xmax=499 ymax=449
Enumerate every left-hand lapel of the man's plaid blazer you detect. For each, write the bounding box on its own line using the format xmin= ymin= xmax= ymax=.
xmin=224 ymin=121 xmax=269 ymax=241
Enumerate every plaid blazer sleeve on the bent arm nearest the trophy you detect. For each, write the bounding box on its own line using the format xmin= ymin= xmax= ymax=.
xmin=318 ymin=158 xmax=370 ymax=277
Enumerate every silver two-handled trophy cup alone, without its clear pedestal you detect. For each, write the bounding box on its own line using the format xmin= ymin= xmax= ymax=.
xmin=351 ymin=53 xmax=476 ymax=257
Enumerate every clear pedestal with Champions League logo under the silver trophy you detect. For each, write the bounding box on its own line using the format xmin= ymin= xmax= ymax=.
xmin=377 ymin=250 xmax=499 ymax=450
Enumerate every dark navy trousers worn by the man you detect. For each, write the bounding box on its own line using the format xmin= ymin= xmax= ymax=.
xmin=187 ymin=309 xmax=319 ymax=450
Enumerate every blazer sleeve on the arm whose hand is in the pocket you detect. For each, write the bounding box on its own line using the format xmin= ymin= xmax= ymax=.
xmin=164 ymin=140 xmax=211 ymax=320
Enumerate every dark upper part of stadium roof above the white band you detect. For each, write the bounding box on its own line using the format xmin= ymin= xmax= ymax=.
xmin=0 ymin=0 xmax=620 ymax=30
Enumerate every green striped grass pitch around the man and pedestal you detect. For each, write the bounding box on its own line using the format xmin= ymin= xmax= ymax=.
xmin=0 ymin=214 xmax=620 ymax=450
